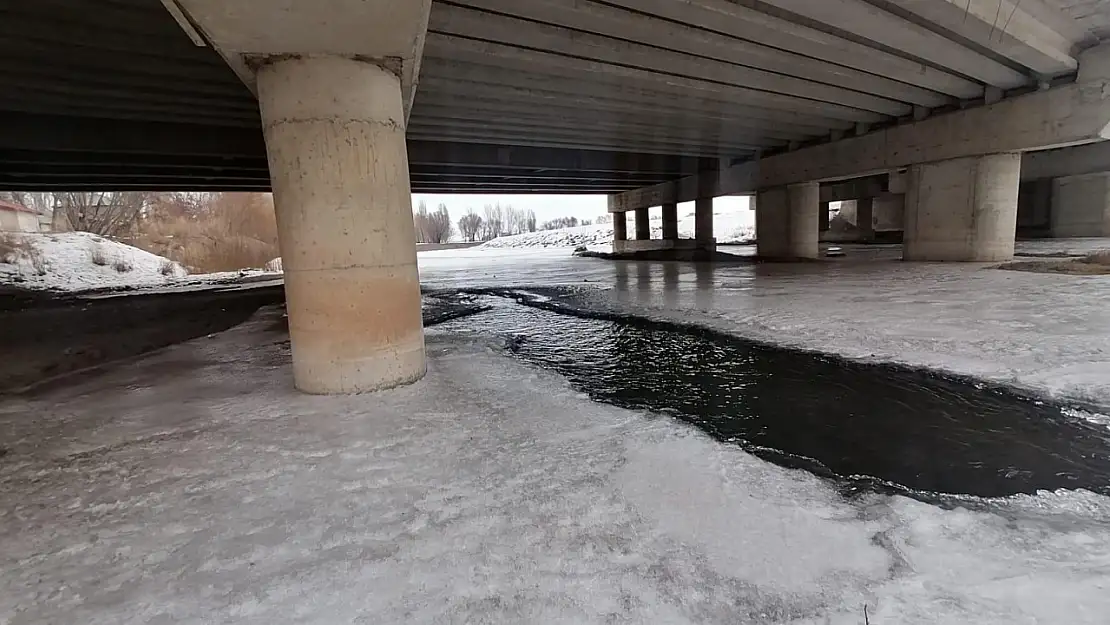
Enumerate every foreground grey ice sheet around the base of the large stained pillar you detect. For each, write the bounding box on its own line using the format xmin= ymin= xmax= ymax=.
xmin=0 ymin=311 xmax=1110 ymax=625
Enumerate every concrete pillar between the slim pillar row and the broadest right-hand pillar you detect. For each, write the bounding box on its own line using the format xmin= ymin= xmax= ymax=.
xmin=756 ymin=182 xmax=821 ymax=259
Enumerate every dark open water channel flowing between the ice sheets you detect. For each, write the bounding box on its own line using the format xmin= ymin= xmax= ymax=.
xmin=430 ymin=291 xmax=1110 ymax=496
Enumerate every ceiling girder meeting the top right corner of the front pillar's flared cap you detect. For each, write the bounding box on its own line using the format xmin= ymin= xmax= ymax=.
xmin=428 ymin=4 xmax=911 ymax=117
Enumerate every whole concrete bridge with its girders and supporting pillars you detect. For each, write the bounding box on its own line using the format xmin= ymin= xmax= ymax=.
xmin=0 ymin=0 xmax=1110 ymax=392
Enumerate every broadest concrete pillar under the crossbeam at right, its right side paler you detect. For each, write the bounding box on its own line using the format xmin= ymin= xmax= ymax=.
xmin=902 ymin=153 xmax=1021 ymax=262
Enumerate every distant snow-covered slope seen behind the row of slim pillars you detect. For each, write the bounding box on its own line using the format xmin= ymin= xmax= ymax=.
xmin=481 ymin=210 xmax=756 ymax=249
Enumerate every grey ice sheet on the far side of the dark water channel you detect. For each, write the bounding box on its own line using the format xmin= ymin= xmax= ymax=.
xmin=420 ymin=247 xmax=1110 ymax=412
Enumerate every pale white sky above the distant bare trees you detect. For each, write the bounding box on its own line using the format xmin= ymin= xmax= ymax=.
xmin=413 ymin=193 xmax=748 ymax=223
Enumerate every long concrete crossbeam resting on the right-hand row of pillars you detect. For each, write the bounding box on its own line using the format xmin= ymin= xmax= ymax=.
xmin=609 ymin=80 xmax=1110 ymax=211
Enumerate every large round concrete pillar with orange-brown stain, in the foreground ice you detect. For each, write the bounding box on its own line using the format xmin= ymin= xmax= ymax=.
xmin=258 ymin=57 xmax=425 ymax=393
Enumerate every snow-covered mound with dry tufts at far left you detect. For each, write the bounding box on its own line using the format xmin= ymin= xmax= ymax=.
xmin=0 ymin=232 xmax=186 ymax=291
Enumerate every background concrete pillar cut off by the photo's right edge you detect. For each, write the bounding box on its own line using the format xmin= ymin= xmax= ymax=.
xmin=1049 ymin=173 xmax=1110 ymax=238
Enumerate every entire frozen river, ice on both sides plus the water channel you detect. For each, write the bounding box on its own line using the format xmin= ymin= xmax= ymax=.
xmin=0 ymin=250 xmax=1110 ymax=625
